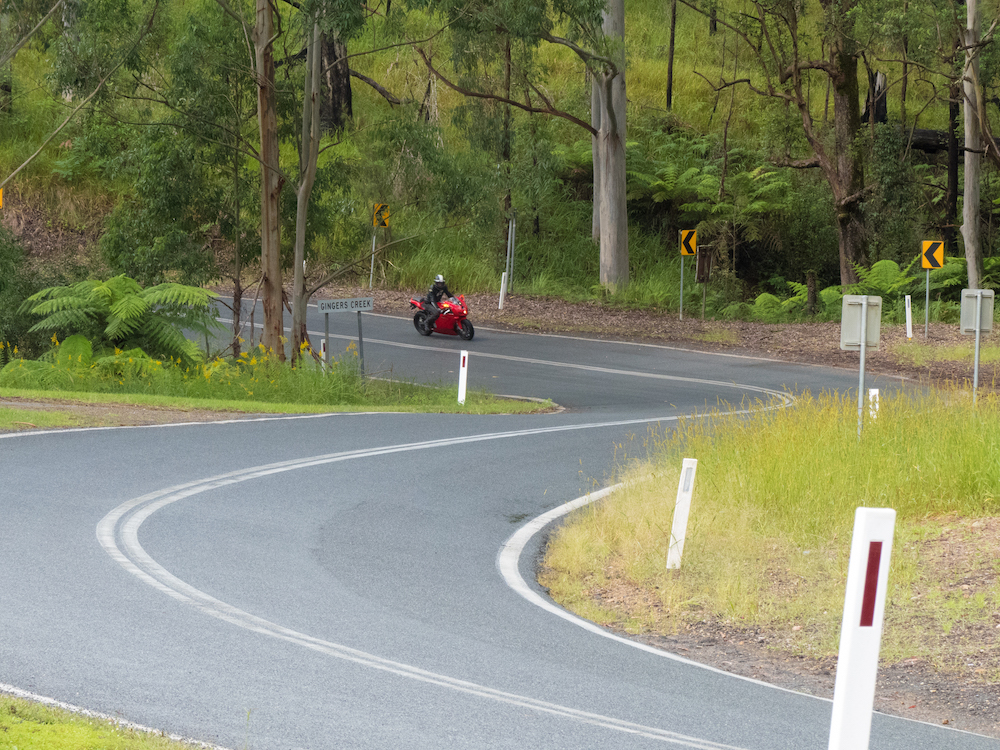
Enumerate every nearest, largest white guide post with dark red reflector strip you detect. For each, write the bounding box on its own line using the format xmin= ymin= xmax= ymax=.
xmin=829 ymin=508 xmax=896 ymax=750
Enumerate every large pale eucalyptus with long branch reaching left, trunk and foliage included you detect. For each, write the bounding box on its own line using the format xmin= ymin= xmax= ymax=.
xmin=410 ymin=0 xmax=628 ymax=289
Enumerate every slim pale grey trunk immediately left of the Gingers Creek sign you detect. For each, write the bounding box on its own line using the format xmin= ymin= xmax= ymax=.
xmin=292 ymin=20 xmax=322 ymax=363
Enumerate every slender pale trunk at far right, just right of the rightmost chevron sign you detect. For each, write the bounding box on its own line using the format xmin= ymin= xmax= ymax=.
xmin=962 ymin=0 xmax=983 ymax=289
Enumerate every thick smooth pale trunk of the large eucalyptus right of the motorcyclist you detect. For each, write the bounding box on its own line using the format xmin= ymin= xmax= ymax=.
xmin=595 ymin=0 xmax=629 ymax=292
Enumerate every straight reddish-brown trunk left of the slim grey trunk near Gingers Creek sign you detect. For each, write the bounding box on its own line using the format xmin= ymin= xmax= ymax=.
xmin=253 ymin=0 xmax=285 ymax=362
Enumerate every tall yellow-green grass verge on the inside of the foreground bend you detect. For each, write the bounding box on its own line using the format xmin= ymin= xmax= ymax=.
xmin=540 ymin=391 xmax=1000 ymax=680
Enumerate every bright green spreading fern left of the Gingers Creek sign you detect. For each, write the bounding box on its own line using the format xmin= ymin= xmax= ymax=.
xmin=24 ymin=275 xmax=220 ymax=366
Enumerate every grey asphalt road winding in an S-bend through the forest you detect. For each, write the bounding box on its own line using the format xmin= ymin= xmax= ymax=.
xmin=0 ymin=304 xmax=1000 ymax=750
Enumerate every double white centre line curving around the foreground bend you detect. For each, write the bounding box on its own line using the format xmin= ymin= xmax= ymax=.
xmin=96 ymin=416 xmax=772 ymax=750
